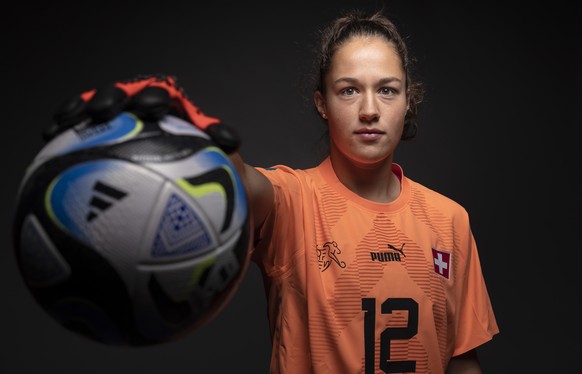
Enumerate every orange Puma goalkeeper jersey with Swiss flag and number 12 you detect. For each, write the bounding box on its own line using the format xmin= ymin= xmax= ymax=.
xmin=252 ymin=158 xmax=499 ymax=374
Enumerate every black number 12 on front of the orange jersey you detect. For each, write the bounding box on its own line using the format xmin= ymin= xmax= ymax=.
xmin=362 ymin=298 xmax=418 ymax=374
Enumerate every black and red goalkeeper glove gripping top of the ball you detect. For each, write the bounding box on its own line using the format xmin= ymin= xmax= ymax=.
xmin=43 ymin=75 xmax=240 ymax=154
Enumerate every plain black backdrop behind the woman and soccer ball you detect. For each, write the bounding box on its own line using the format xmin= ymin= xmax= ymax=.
xmin=0 ymin=0 xmax=582 ymax=374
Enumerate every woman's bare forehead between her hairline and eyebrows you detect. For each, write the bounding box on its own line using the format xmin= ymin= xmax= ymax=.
xmin=329 ymin=36 xmax=404 ymax=78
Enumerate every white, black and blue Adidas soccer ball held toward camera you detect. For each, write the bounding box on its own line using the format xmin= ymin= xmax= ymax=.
xmin=13 ymin=113 xmax=252 ymax=346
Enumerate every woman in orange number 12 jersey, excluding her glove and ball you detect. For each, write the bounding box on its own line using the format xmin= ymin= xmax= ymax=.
xmin=239 ymin=9 xmax=498 ymax=373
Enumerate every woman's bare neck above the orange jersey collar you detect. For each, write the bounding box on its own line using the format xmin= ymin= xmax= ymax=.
xmin=330 ymin=152 xmax=400 ymax=203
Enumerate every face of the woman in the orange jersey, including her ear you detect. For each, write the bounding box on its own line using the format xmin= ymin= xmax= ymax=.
xmin=315 ymin=36 xmax=407 ymax=167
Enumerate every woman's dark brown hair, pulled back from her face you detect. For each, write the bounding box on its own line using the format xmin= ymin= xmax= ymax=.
xmin=315 ymin=10 xmax=424 ymax=140
